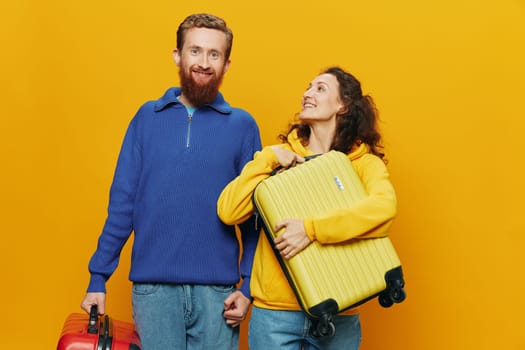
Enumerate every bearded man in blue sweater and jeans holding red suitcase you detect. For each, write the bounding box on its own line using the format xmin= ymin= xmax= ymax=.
xmin=81 ymin=14 xmax=261 ymax=350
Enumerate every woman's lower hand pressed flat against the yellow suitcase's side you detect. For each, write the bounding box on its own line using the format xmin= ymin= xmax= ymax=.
xmin=274 ymin=219 xmax=312 ymax=259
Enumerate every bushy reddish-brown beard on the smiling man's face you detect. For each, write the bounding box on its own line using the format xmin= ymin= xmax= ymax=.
xmin=179 ymin=65 xmax=224 ymax=107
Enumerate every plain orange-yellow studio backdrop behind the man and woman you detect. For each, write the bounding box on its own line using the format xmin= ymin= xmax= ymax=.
xmin=0 ymin=0 xmax=525 ymax=350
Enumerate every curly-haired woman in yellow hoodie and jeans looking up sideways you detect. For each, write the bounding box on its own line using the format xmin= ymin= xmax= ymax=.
xmin=218 ymin=67 xmax=396 ymax=350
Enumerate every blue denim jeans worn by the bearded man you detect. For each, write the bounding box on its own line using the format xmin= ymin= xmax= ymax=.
xmin=132 ymin=283 xmax=239 ymax=350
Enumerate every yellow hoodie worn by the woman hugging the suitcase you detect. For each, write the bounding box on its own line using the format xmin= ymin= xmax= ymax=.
xmin=217 ymin=131 xmax=397 ymax=310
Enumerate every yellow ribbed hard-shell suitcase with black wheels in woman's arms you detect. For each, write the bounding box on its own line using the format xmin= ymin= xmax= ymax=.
xmin=253 ymin=151 xmax=406 ymax=336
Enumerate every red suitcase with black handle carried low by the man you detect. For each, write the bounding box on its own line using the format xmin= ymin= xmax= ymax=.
xmin=57 ymin=305 xmax=140 ymax=350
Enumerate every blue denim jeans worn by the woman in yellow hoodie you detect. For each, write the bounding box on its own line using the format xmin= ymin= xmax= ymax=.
xmin=248 ymin=306 xmax=361 ymax=350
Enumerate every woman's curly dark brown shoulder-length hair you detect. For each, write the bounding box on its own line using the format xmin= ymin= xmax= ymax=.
xmin=279 ymin=67 xmax=386 ymax=161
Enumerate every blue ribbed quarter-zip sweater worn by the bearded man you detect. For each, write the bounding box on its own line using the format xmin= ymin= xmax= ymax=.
xmin=88 ymin=88 xmax=261 ymax=296
